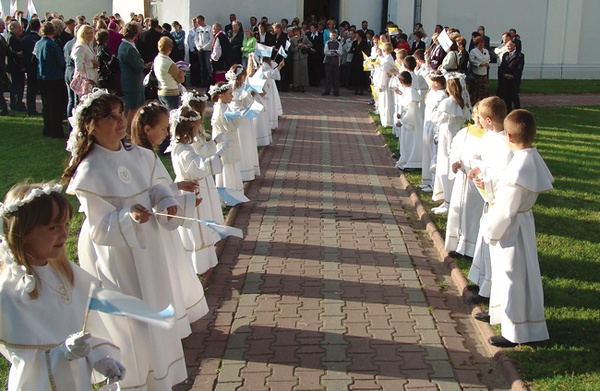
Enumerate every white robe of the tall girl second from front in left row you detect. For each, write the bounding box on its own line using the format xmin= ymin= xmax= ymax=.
xmin=67 ymin=144 xmax=189 ymax=390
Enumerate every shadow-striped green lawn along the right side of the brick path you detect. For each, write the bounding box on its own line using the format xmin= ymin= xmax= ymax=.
xmin=378 ymin=106 xmax=600 ymax=391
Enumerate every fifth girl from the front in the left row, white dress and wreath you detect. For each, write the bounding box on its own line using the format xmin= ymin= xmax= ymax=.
xmin=208 ymin=82 xmax=244 ymax=192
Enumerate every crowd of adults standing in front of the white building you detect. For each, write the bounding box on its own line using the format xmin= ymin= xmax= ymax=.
xmin=0 ymin=8 xmax=524 ymax=138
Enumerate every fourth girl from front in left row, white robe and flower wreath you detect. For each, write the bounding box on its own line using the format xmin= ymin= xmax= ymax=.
xmin=171 ymin=106 xmax=227 ymax=275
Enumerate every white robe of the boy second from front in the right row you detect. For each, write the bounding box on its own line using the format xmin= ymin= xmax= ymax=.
xmin=467 ymin=130 xmax=513 ymax=297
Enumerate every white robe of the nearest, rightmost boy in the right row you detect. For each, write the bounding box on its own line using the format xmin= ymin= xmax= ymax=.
xmin=481 ymin=148 xmax=554 ymax=343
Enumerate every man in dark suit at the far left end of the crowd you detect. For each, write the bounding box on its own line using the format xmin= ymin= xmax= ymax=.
xmin=6 ymin=20 xmax=27 ymax=111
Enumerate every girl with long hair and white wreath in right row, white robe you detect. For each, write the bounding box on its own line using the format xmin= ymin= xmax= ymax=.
xmin=431 ymin=73 xmax=471 ymax=214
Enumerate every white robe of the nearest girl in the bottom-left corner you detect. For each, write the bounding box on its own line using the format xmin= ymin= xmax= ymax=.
xmin=0 ymin=264 xmax=122 ymax=391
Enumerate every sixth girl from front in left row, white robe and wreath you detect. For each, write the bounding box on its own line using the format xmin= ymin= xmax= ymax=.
xmin=225 ymin=64 xmax=260 ymax=182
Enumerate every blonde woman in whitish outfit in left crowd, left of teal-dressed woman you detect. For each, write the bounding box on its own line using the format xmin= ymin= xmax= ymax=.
xmin=70 ymin=25 xmax=99 ymax=97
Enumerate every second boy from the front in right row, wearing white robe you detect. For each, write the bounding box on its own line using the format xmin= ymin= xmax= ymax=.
xmin=467 ymin=96 xmax=512 ymax=306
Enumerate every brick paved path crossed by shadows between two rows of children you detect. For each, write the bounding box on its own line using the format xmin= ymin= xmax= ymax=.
xmin=176 ymin=89 xmax=509 ymax=391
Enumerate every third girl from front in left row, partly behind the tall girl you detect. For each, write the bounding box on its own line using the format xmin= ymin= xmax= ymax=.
xmin=131 ymin=100 xmax=208 ymax=316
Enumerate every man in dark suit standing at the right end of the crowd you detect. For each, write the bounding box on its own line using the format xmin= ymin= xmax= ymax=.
xmin=496 ymin=41 xmax=525 ymax=112
